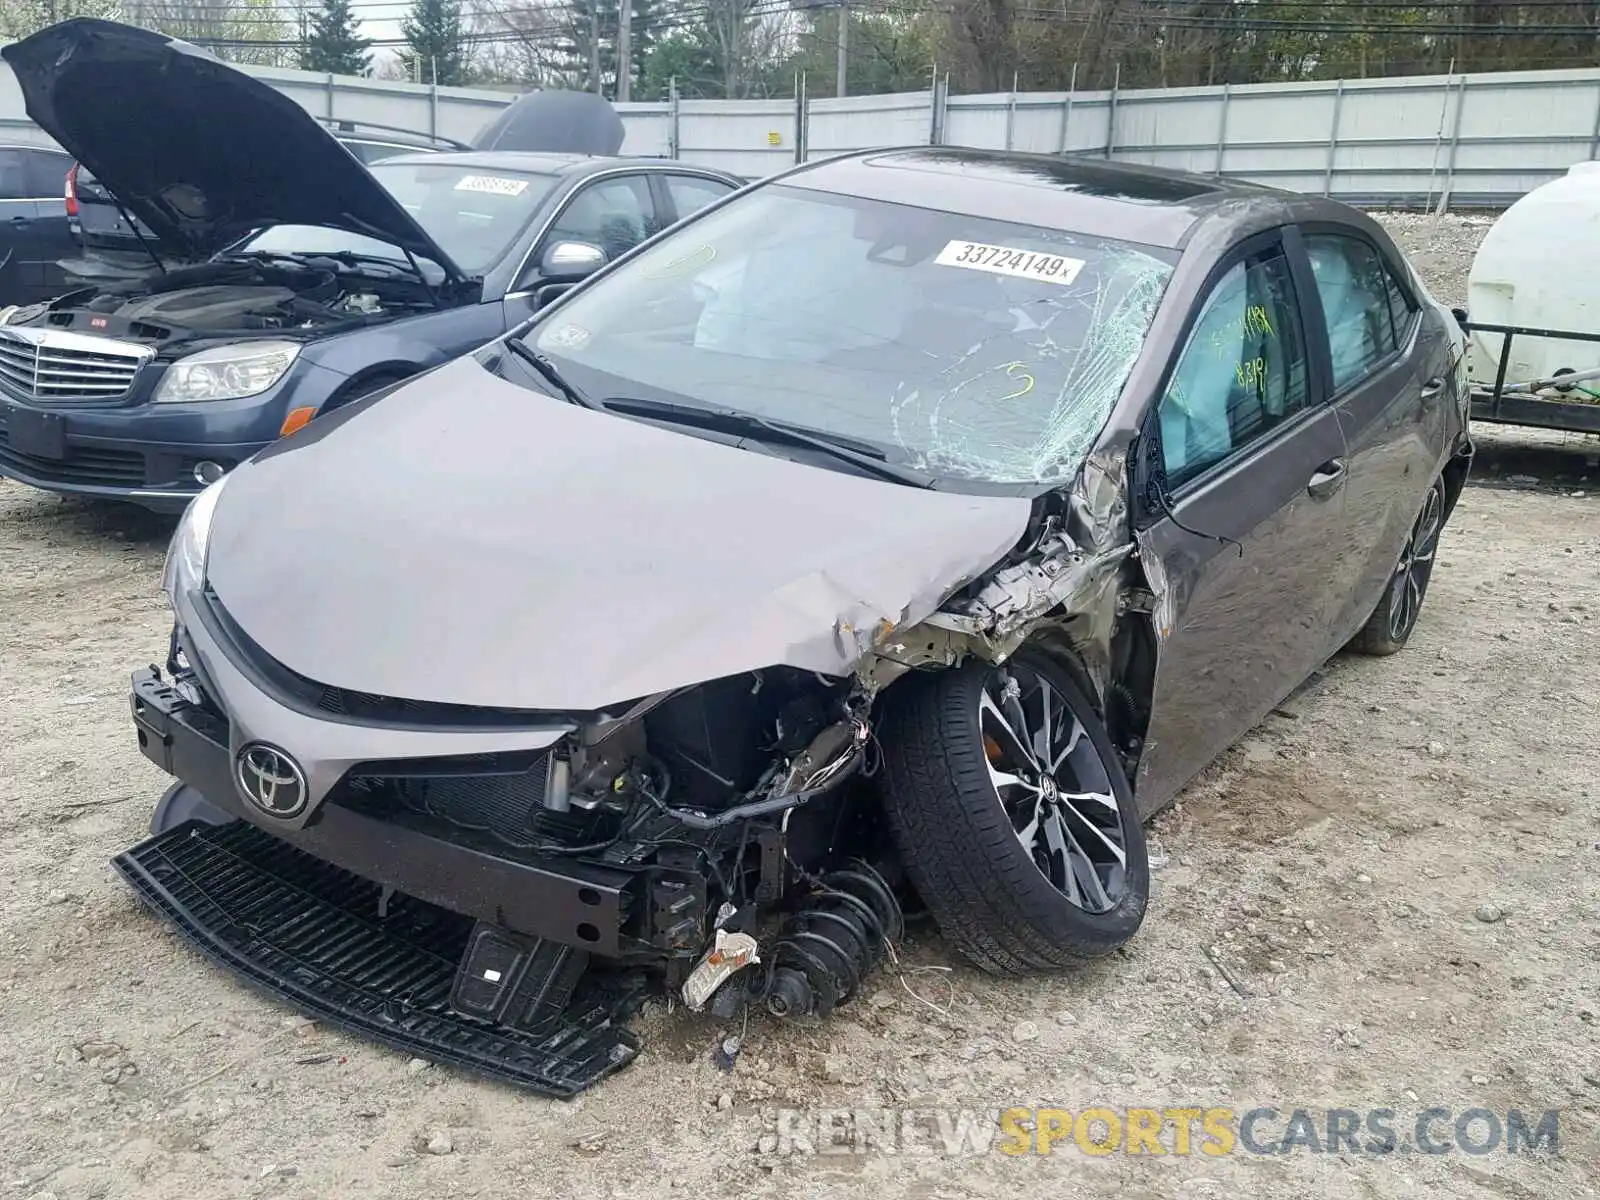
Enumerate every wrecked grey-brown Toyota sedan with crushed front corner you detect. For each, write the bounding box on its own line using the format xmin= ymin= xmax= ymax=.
xmin=117 ymin=149 xmax=1470 ymax=1094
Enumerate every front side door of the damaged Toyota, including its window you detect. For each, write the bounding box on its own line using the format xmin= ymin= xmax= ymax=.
xmin=1136 ymin=235 xmax=1344 ymax=813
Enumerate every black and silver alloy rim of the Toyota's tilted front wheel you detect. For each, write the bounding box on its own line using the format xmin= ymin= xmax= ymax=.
xmin=978 ymin=662 xmax=1128 ymax=912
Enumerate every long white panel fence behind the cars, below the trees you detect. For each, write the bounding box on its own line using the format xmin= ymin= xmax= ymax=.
xmin=0 ymin=51 xmax=1600 ymax=205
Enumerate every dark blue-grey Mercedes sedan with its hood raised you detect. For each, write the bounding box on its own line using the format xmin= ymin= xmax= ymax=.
xmin=0 ymin=19 xmax=739 ymax=509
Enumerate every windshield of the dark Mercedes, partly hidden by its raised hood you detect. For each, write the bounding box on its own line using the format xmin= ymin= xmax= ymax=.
xmin=235 ymin=162 xmax=555 ymax=275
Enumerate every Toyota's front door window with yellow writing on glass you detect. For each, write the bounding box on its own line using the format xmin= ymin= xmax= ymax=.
xmin=1158 ymin=251 xmax=1309 ymax=486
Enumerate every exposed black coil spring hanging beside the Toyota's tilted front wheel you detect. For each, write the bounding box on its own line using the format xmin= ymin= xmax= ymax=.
xmin=748 ymin=859 xmax=906 ymax=1018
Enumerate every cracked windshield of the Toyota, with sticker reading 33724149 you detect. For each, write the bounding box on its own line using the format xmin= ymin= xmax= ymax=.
xmin=525 ymin=186 xmax=1176 ymax=485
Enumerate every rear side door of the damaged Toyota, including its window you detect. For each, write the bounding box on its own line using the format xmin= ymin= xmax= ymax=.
xmin=1304 ymin=226 xmax=1450 ymax=645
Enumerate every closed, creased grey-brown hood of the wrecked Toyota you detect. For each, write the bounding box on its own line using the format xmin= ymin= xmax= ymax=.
xmin=208 ymin=358 xmax=1030 ymax=712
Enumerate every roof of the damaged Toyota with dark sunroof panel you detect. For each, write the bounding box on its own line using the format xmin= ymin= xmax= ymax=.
xmin=778 ymin=146 xmax=1309 ymax=250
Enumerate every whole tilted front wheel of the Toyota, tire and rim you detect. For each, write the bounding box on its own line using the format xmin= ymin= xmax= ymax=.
xmin=880 ymin=651 xmax=1150 ymax=974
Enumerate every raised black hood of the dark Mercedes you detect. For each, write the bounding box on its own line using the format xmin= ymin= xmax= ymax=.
xmin=0 ymin=18 xmax=461 ymax=278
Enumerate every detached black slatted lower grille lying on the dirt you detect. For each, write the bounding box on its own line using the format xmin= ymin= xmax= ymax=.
xmin=112 ymin=821 xmax=638 ymax=1098
